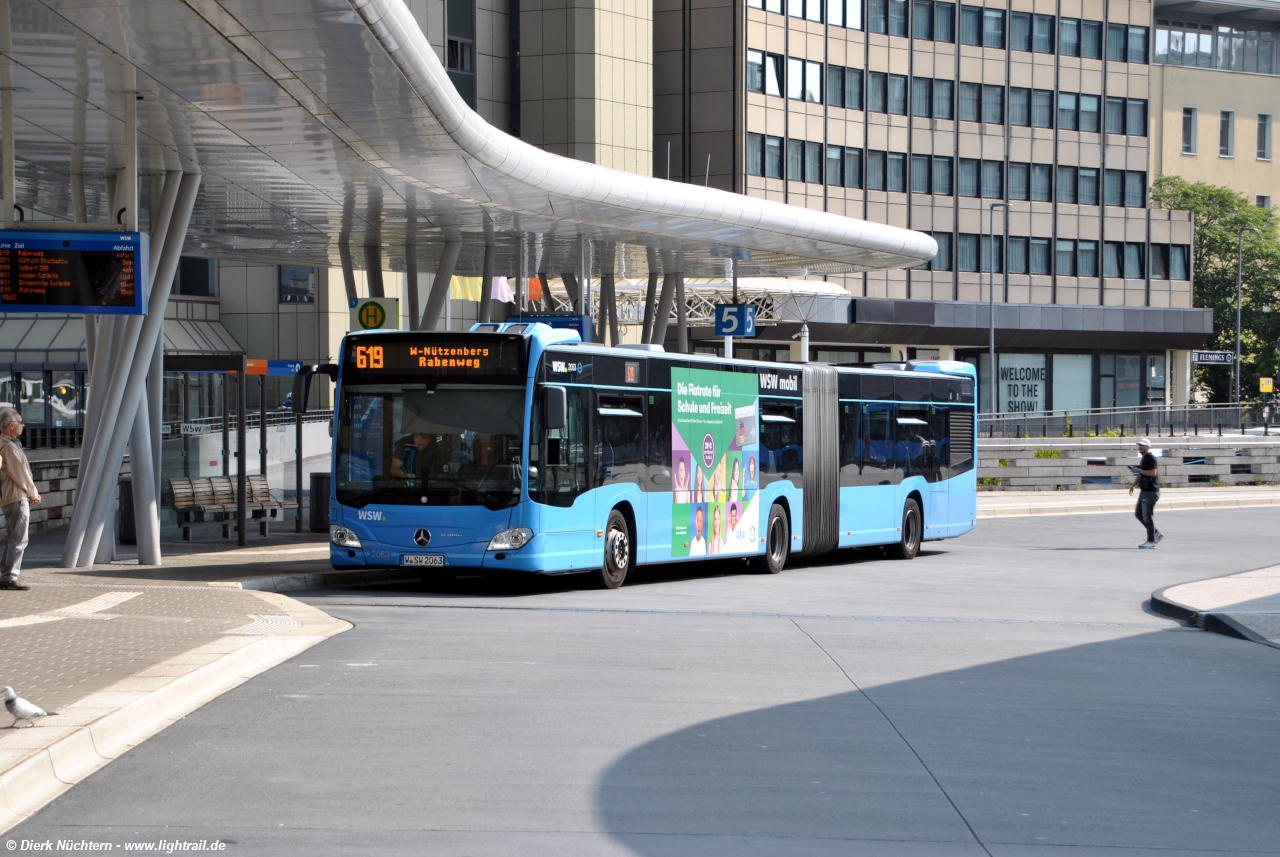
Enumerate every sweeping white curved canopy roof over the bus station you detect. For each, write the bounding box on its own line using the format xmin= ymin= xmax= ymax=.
xmin=0 ymin=0 xmax=936 ymax=276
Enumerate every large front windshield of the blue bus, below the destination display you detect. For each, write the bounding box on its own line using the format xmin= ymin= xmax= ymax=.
xmin=335 ymin=384 xmax=525 ymax=509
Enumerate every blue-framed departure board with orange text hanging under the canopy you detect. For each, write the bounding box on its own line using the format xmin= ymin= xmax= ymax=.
xmin=0 ymin=229 xmax=148 ymax=315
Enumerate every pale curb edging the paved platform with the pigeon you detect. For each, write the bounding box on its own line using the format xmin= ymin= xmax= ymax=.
xmin=0 ymin=591 xmax=353 ymax=834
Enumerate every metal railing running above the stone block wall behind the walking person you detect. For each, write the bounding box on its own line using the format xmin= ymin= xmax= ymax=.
xmin=978 ymin=403 xmax=1280 ymax=437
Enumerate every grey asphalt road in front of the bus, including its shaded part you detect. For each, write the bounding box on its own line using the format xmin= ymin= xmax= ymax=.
xmin=6 ymin=509 xmax=1280 ymax=857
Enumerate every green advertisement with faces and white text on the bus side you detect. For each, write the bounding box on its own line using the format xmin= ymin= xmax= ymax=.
xmin=671 ymin=367 xmax=760 ymax=558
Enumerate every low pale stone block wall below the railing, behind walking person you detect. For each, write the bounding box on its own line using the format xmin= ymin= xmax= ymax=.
xmin=978 ymin=436 xmax=1280 ymax=491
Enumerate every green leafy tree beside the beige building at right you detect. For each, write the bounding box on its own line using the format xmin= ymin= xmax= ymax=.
xmin=1151 ymin=175 xmax=1280 ymax=402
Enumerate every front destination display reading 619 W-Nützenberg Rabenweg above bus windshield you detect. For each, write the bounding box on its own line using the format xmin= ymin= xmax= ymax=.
xmin=347 ymin=334 xmax=525 ymax=377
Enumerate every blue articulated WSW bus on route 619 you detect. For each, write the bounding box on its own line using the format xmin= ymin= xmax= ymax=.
xmin=329 ymin=324 xmax=977 ymax=588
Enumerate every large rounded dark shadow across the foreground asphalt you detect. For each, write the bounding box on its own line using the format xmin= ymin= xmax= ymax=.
xmin=596 ymin=631 xmax=1280 ymax=857
